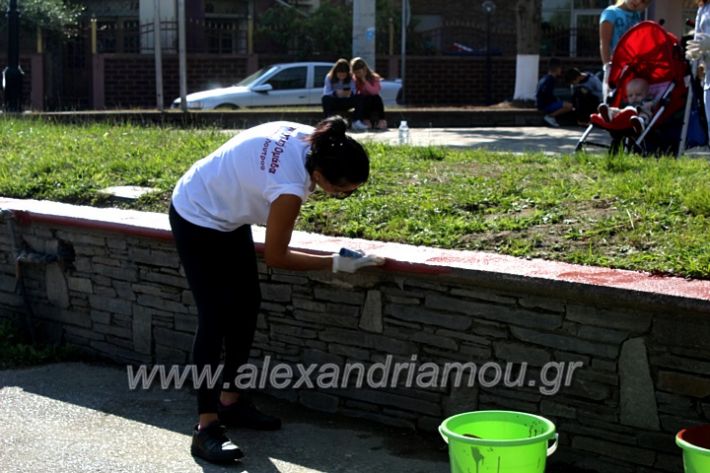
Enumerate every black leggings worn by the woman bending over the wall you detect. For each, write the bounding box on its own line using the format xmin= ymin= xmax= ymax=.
xmin=169 ymin=205 xmax=261 ymax=414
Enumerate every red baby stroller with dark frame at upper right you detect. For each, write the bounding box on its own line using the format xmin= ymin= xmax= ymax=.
xmin=576 ymin=21 xmax=692 ymax=155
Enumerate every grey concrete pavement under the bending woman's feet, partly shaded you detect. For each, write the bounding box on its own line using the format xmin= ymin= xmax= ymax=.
xmin=0 ymin=363 xmax=449 ymax=473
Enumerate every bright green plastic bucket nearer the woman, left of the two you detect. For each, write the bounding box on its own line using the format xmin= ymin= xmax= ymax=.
xmin=439 ymin=411 xmax=557 ymax=473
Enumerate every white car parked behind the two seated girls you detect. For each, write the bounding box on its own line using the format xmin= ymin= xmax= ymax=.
xmin=172 ymin=62 xmax=401 ymax=110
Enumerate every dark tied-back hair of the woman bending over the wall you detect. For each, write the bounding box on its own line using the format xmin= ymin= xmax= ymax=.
xmin=306 ymin=115 xmax=370 ymax=186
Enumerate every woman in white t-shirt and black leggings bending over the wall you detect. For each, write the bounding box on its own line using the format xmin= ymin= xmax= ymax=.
xmin=169 ymin=116 xmax=383 ymax=463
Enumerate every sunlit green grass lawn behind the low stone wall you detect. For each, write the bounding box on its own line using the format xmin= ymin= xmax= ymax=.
xmin=0 ymin=118 xmax=710 ymax=279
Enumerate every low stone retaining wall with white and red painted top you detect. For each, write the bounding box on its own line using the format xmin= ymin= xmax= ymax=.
xmin=0 ymin=199 xmax=710 ymax=473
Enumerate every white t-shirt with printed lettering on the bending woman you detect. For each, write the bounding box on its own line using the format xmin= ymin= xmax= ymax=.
xmin=172 ymin=122 xmax=313 ymax=232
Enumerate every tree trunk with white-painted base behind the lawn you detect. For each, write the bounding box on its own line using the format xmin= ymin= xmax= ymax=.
xmin=513 ymin=0 xmax=542 ymax=101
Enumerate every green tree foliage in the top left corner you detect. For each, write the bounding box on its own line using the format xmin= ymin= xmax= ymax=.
xmin=0 ymin=0 xmax=84 ymax=36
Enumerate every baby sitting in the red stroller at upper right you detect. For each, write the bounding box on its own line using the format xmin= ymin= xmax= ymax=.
xmin=597 ymin=77 xmax=658 ymax=135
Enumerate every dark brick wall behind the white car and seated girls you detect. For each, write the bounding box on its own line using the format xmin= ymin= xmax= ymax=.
xmin=98 ymin=55 xmax=599 ymax=108
